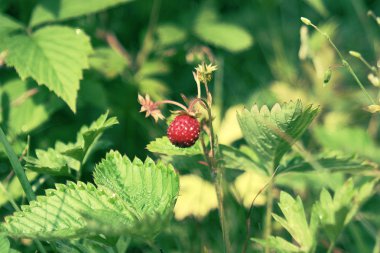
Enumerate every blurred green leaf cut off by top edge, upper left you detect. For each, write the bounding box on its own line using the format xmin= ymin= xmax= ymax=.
xmin=30 ymin=0 xmax=131 ymax=26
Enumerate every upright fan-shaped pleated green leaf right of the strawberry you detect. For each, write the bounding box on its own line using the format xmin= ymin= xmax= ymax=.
xmin=238 ymin=100 xmax=319 ymax=169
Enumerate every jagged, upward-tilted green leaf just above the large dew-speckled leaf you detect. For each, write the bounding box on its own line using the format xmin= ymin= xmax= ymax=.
xmin=24 ymin=112 xmax=118 ymax=175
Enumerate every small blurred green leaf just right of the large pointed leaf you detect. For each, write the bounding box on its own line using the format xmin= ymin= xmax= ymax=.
xmin=90 ymin=47 xmax=128 ymax=78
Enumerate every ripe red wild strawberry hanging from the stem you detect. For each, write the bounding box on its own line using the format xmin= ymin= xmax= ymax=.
xmin=167 ymin=114 xmax=200 ymax=148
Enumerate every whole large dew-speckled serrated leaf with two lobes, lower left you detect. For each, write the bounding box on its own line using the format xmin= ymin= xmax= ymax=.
xmin=3 ymin=151 xmax=179 ymax=240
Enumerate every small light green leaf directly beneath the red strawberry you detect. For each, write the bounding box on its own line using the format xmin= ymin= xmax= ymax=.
xmin=146 ymin=136 xmax=203 ymax=156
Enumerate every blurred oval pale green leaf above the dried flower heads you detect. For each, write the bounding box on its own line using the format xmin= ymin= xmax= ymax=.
xmin=194 ymin=22 xmax=253 ymax=53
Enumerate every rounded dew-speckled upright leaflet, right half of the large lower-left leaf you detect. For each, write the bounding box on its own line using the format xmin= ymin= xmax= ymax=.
xmin=94 ymin=151 xmax=179 ymax=220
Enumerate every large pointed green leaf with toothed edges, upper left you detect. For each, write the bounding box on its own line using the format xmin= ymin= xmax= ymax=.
xmin=3 ymin=26 xmax=92 ymax=112
